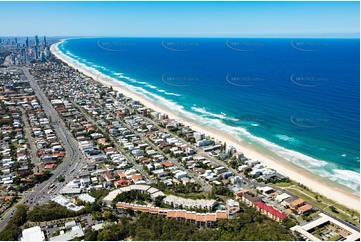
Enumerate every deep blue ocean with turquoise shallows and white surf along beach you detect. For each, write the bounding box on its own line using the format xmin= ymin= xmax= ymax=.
xmin=59 ymin=38 xmax=360 ymax=194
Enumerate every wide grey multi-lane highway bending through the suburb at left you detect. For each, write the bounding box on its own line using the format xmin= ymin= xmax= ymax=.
xmin=0 ymin=67 xmax=87 ymax=231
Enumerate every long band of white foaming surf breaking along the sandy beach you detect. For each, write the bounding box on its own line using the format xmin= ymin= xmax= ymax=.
xmin=54 ymin=41 xmax=360 ymax=191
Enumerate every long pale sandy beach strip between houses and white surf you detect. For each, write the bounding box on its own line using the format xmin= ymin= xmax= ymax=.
xmin=50 ymin=42 xmax=360 ymax=211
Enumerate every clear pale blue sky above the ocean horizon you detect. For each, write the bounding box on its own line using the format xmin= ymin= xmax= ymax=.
xmin=0 ymin=2 xmax=360 ymax=38
